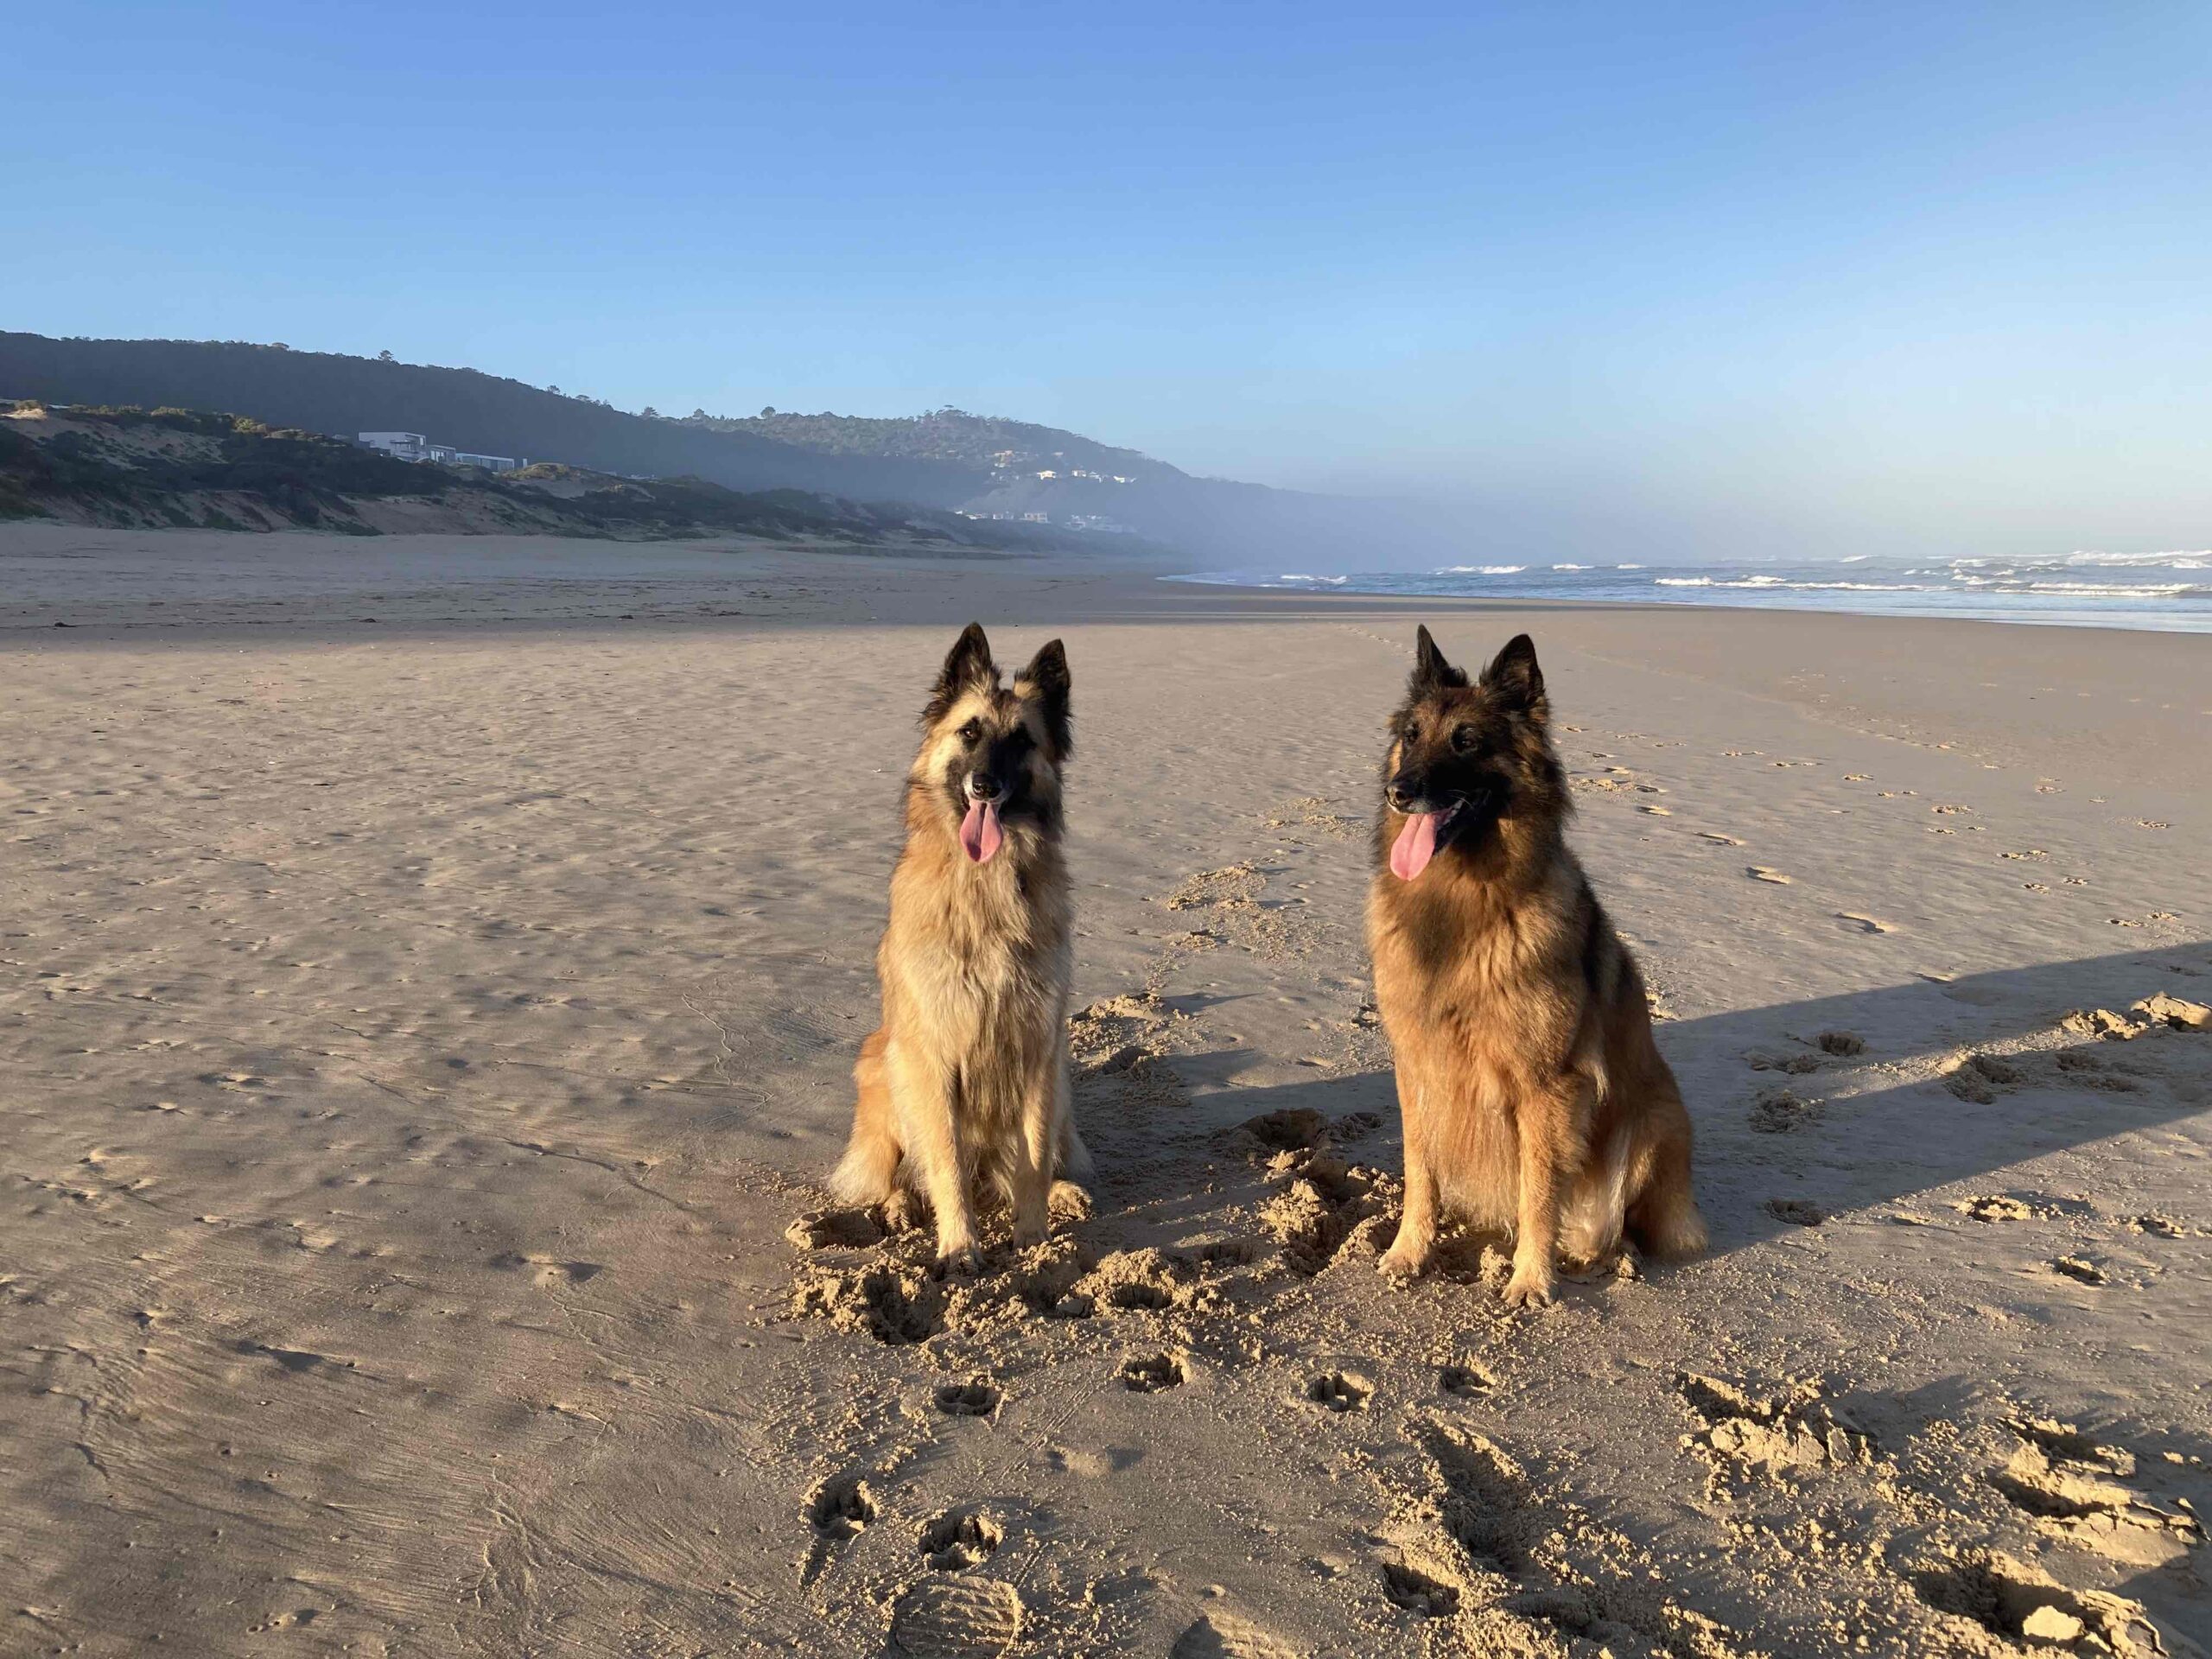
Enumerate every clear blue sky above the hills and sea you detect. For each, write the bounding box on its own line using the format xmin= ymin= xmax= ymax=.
xmin=0 ymin=0 xmax=2212 ymax=557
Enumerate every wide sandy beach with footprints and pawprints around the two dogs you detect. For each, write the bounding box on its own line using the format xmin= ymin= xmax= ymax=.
xmin=0 ymin=526 xmax=2212 ymax=1659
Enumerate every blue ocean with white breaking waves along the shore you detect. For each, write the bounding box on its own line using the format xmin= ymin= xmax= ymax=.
xmin=1173 ymin=550 xmax=2212 ymax=632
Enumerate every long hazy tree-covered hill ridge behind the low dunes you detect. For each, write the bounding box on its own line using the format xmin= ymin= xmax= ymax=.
xmin=0 ymin=332 xmax=1445 ymax=569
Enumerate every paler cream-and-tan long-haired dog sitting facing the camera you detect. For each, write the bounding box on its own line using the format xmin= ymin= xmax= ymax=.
xmin=830 ymin=621 xmax=1090 ymax=1272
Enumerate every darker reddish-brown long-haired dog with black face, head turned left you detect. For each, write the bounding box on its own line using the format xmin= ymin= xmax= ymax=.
xmin=1367 ymin=628 xmax=1706 ymax=1307
